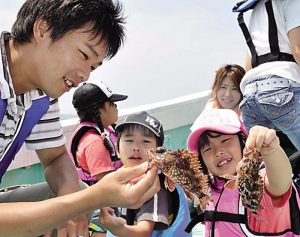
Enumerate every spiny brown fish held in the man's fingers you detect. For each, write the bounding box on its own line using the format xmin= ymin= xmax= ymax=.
xmin=148 ymin=147 xmax=212 ymax=210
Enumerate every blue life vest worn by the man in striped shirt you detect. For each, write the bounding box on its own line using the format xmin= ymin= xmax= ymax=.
xmin=0 ymin=95 xmax=50 ymax=180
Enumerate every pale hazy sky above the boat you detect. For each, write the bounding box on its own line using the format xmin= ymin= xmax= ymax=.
xmin=0 ymin=0 xmax=246 ymax=114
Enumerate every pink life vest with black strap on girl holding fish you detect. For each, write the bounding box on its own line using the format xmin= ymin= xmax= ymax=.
xmin=186 ymin=177 xmax=300 ymax=237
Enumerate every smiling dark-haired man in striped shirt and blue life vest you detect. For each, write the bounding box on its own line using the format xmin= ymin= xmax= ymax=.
xmin=0 ymin=0 xmax=158 ymax=236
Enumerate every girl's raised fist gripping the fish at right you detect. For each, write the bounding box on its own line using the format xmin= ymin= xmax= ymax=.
xmin=246 ymin=126 xmax=280 ymax=156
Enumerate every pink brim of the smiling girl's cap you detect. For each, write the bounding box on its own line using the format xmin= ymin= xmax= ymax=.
xmin=187 ymin=124 xmax=241 ymax=151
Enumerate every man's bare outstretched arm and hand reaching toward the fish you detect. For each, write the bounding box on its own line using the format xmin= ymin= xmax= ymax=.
xmin=0 ymin=163 xmax=160 ymax=237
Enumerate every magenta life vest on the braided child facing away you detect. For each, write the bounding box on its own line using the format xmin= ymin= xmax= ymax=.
xmin=69 ymin=122 xmax=122 ymax=185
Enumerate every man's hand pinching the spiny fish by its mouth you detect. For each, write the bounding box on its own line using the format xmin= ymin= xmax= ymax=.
xmin=90 ymin=162 xmax=160 ymax=209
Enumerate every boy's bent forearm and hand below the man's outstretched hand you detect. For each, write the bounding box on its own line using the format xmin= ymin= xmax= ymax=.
xmin=99 ymin=208 xmax=154 ymax=237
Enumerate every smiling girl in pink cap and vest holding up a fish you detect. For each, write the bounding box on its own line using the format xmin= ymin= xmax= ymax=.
xmin=187 ymin=109 xmax=300 ymax=237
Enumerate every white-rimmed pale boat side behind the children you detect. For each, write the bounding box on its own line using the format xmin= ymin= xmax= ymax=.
xmin=5 ymin=90 xmax=210 ymax=170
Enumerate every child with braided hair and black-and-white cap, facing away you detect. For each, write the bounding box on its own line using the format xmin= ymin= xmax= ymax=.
xmin=69 ymin=80 xmax=127 ymax=237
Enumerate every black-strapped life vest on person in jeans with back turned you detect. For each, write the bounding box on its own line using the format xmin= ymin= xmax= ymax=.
xmin=232 ymin=0 xmax=296 ymax=68
